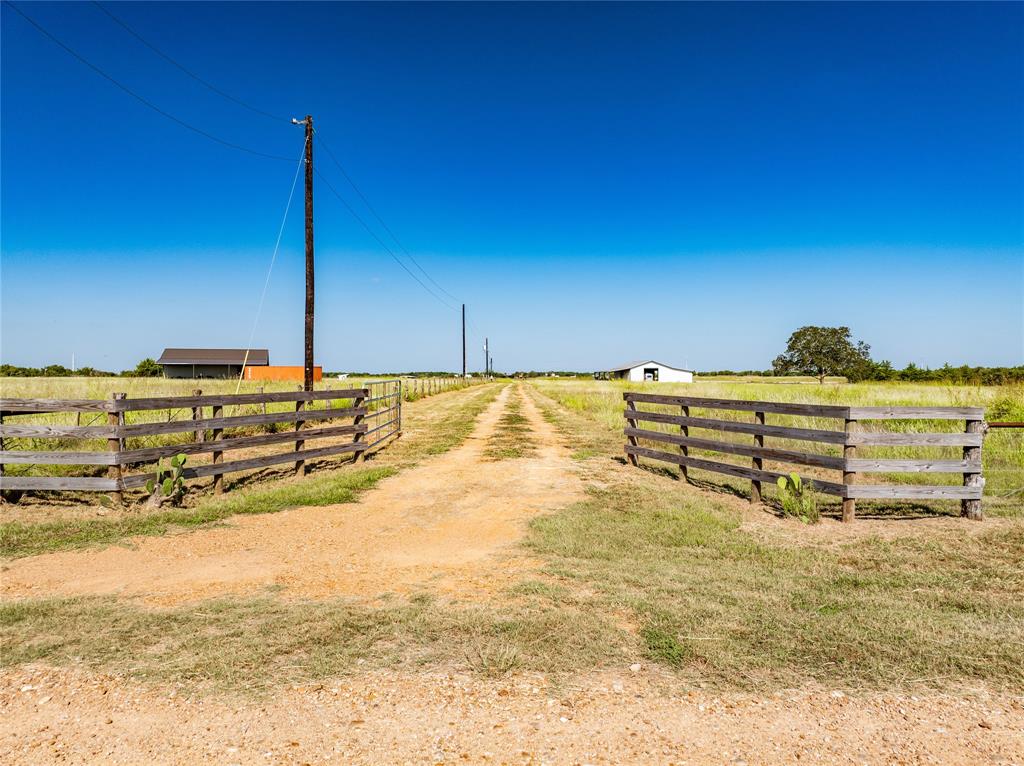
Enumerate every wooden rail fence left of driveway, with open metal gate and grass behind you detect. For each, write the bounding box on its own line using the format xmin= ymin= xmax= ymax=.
xmin=0 ymin=380 xmax=402 ymax=501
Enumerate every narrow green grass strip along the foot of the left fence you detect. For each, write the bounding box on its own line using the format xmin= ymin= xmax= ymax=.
xmin=0 ymin=466 xmax=395 ymax=558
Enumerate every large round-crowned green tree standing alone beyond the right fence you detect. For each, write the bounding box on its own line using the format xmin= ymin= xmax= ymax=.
xmin=772 ymin=326 xmax=871 ymax=383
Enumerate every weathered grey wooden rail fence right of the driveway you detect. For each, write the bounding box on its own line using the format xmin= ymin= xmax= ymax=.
xmin=624 ymin=391 xmax=985 ymax=521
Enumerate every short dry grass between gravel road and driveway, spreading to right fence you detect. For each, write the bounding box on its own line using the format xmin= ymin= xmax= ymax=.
xmin=0 ymin=378 xmax=1024 ymax=693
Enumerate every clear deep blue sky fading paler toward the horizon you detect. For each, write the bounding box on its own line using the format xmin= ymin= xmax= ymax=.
xmin=0 ymin=3 xmax=1024 ymax=371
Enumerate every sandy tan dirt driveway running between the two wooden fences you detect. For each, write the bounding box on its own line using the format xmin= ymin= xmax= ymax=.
xmin=0 ymin=387 xmax=583 ymax=605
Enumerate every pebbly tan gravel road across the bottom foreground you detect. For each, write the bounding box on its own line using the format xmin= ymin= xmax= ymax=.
xmin=0 ymin=668 xmax=1024 ymax=766
